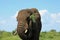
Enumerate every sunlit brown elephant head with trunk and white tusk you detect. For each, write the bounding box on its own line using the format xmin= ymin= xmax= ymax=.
xmin=17 ymin=9 xmax=32 ymax=39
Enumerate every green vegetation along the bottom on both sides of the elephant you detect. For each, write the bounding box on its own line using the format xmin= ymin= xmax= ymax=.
xmin=0 ymin=30 xmax=60 ymax=40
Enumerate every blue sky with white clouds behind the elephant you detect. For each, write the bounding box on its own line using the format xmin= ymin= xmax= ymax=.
xmin=0 ymin=0 xmax=60 ymax=31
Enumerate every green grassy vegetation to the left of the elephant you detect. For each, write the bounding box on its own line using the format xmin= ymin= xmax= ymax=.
xmin=0 ymin=31 xmax=19 ymax=40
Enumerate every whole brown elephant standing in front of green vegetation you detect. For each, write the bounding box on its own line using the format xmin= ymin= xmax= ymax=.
xmin=17 ymin=8 xmax=42 ymax=40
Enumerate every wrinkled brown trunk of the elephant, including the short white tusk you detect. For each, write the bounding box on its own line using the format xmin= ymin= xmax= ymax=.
xmin=17 ymin=21 xmax=28 ymax=40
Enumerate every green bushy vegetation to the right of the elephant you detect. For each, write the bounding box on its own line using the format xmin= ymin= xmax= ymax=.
xmin=40 ymin=30 xmax=60 ymax=40
